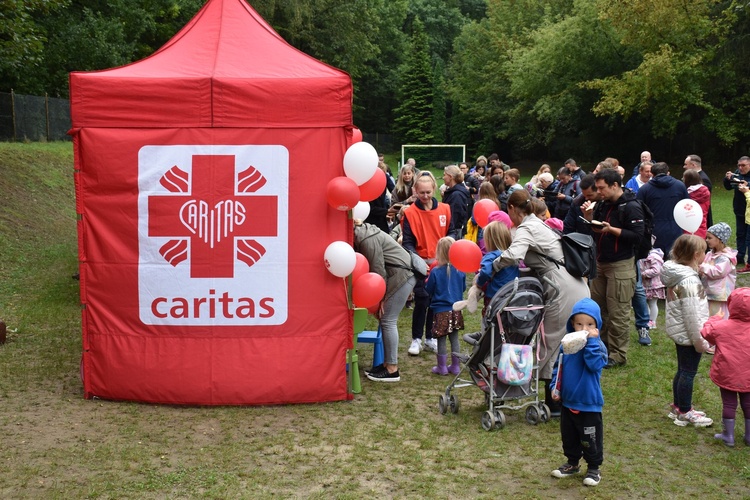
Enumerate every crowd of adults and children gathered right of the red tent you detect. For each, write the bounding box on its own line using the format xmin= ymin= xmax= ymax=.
xmin=355 ymin=151 xmax=750 ymax=486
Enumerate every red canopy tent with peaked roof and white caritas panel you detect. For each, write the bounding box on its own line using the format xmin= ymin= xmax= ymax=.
xmin=70 ymin=0 xmax=352 ymax=404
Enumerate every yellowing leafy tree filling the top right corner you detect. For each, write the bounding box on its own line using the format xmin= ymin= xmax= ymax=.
xmin=587 ymin=0 xmax=750 ymax=144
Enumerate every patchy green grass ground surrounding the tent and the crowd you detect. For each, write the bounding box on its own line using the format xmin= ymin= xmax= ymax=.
xmin=0 ymin=143 xmax=750 ymax=499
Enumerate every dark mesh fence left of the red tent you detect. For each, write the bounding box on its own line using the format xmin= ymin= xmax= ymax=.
xmin=0 ymin=92 xmax=70 ymax=141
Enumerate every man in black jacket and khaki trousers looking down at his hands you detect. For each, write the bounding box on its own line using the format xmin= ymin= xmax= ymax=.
xmin=591 ymin=168 xmax=644 ymax=368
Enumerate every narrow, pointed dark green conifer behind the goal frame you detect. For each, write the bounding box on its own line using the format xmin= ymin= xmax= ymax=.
xmin=394 ymin=19 xmax=433 ymax=144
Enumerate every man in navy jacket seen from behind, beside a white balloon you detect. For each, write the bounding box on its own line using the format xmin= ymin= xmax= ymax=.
xmin=636 ymin=162 xmax=690 ymax=257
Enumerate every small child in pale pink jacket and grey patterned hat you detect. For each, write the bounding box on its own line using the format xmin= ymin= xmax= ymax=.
xmin=698 ymin=222 xmax=737 ymax=319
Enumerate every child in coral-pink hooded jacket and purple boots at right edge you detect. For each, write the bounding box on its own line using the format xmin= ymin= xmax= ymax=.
xmin=701 ymin=288 xmax=750 ymax=446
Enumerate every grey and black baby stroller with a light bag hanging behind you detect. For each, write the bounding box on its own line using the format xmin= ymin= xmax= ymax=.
xmin=438 ymin=277 xmax=550 ymax=431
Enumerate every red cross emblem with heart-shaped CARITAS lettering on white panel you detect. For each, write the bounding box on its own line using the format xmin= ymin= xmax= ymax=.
xmin=148 ymin=155 xmax=278 ymax=278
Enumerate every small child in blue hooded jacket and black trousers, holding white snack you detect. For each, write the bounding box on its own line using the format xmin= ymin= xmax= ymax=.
xmin=552 ymin=298 xmax=608 ymax=486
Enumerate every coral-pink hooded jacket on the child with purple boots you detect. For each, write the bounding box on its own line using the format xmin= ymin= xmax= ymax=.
xmin=701 ymin=288 xmax=750 ymax=392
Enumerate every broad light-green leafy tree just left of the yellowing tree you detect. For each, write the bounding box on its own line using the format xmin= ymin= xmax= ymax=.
xmin=499 ymin=0 xmax=635 ymax=152
